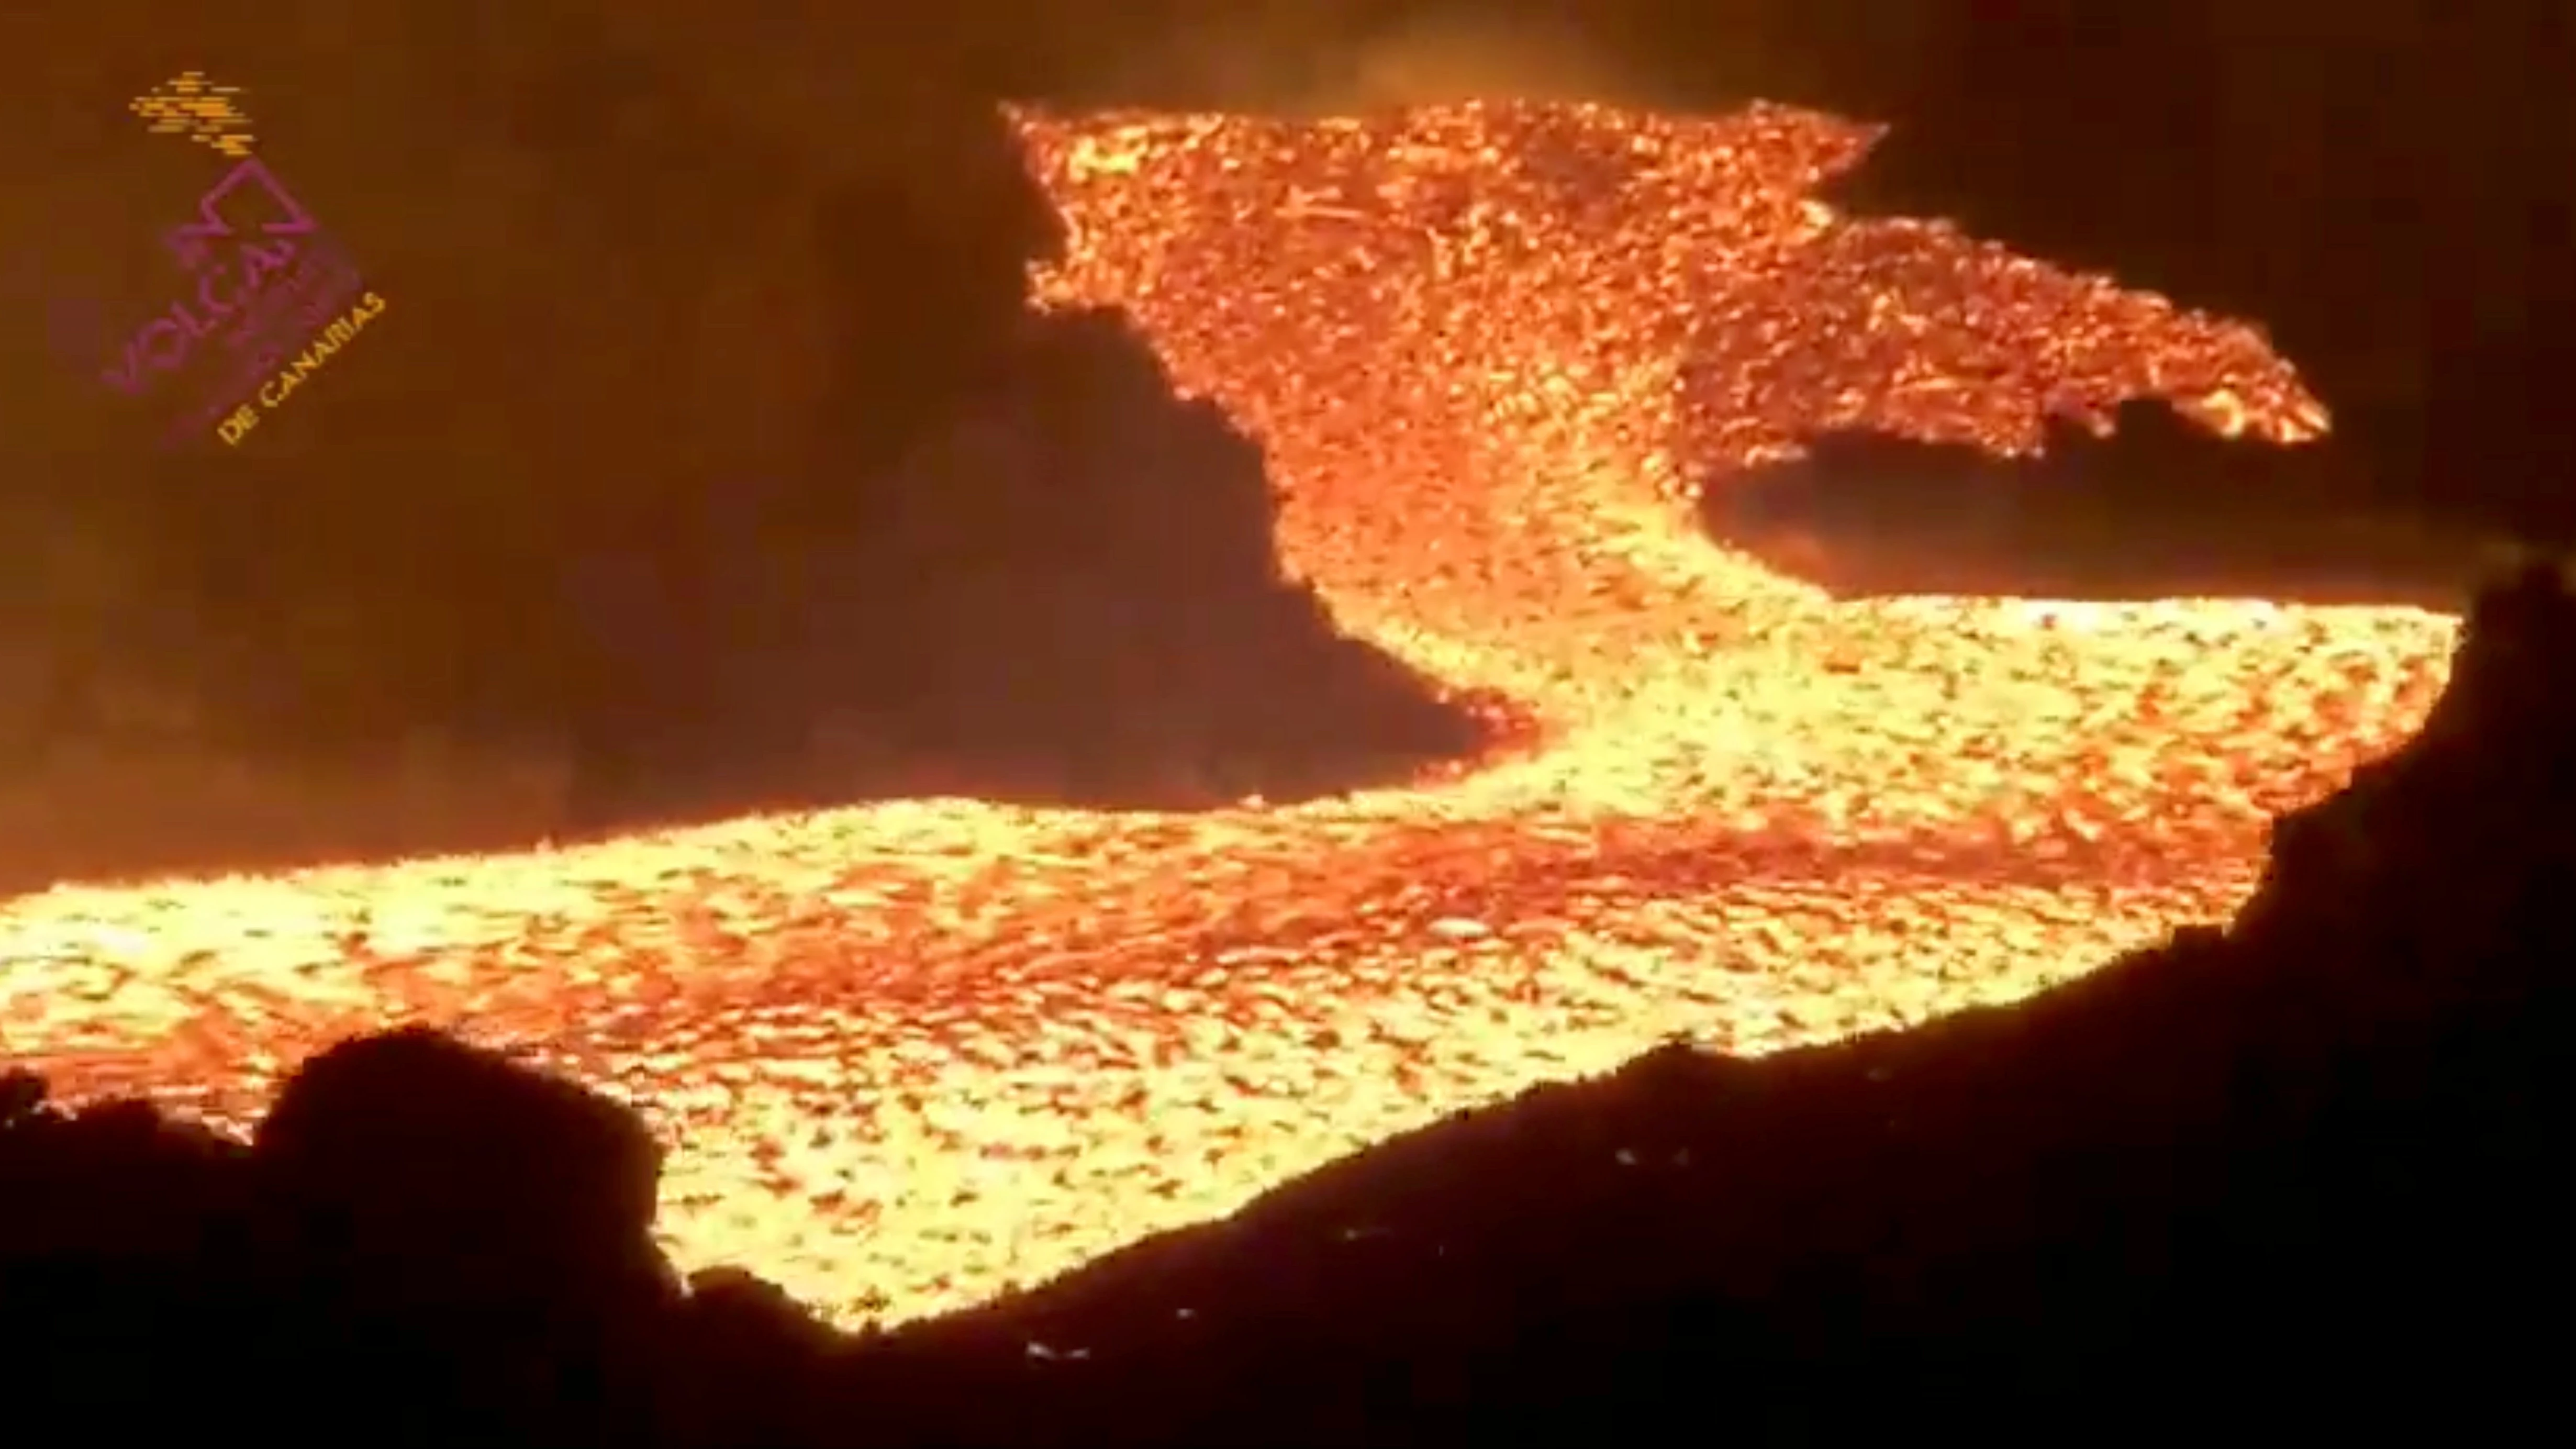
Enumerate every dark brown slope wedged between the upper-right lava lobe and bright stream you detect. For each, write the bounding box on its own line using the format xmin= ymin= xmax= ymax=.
xmin=1700 ymin=392 xmax=2512 ymax=611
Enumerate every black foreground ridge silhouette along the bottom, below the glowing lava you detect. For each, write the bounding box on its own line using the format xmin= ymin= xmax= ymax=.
xmin=0 ymin=559 xmax=2576 ymax=1446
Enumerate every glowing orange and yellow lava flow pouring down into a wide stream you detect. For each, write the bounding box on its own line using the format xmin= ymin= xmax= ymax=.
xmin=0 ymin=106 xmax=2455 ymax=1323
